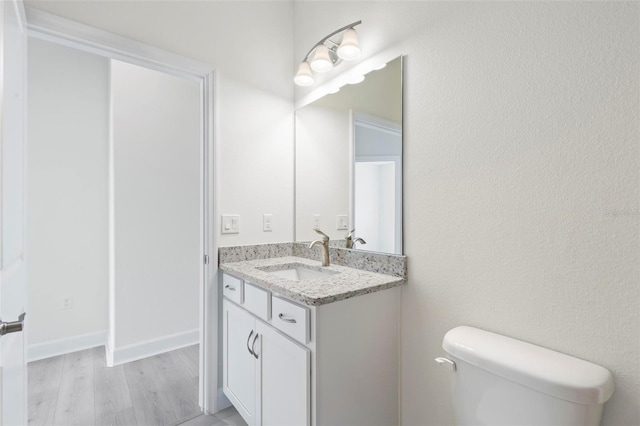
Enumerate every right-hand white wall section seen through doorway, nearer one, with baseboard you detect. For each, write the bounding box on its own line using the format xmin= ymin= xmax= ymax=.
xmin=109 ymin=60 xmax=202 ymax=364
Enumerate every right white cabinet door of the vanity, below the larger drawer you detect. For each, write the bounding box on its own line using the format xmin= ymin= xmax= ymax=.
xmin=256 ymin=321 xmax=311 ymax=426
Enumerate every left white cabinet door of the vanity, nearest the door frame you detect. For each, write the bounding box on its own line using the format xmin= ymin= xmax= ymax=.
xmin=222 ymin=300 xmax=259 ymax=426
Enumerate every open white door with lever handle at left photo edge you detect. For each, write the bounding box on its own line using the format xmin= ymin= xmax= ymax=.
xmin=0 ymin=0 xmax=27 ymax=425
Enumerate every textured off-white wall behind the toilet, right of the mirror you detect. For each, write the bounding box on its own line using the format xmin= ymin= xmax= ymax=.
xmin=294 ymin=2 xmax=640 ymax=426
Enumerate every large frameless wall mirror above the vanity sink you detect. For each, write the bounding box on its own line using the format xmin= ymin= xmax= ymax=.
xmin=295 ymin=57 xmax=403 ymax=254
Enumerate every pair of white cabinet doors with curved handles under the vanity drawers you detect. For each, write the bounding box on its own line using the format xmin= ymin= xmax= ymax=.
xmin=223 ymin=300 xmax=311 ymax=426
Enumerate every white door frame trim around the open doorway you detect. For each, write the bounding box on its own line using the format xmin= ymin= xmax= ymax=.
xmin=25 ymin=6 xmax=219 ymax=413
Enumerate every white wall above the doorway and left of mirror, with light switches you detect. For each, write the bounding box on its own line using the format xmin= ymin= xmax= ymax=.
xmin=26 ymin=0 xmax=295 ymax=245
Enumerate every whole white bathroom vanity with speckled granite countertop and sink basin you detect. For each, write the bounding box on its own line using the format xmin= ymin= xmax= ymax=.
xmin=220 ymin=256 xmax=404 ymax=425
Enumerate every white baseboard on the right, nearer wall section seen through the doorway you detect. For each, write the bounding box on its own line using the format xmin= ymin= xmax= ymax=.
xmin=107 ymin=328 xmax=200 ymax=367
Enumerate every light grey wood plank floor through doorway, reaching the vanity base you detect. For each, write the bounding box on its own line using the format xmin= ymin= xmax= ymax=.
xmin=28 ymin=345 xmax=242 ymax=426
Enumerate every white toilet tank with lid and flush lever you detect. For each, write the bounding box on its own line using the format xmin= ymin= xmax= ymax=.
xmin=436 ymin=327 xmax=613 ymax=426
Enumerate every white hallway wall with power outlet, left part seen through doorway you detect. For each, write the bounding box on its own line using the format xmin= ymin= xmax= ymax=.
xmin=28 ymin=39 xmax=109 ymax=352
